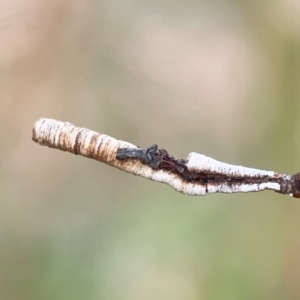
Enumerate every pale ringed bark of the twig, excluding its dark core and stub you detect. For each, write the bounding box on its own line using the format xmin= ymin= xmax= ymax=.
xmin=32 ymin=119 xmax=290 ymax=196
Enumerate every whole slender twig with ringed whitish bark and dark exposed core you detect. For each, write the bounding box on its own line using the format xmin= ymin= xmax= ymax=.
xmin=32 ymin=119 xmax=300 ymax=198
